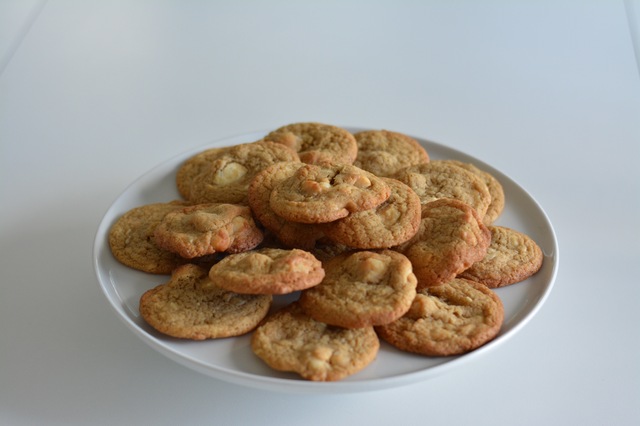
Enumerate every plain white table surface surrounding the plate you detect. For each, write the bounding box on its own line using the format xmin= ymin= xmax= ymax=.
xmin=0 ymin=0 xmax=640 ymax=425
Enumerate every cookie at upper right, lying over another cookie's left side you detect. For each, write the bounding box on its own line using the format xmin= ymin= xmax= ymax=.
xmin=395 ymin=160 xmax=491 ymax=218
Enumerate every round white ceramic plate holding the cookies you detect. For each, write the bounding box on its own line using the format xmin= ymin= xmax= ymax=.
xmin=94 ymin=128 xmax=558 ymax=393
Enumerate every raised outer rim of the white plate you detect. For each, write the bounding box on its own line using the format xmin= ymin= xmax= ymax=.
xmin=92 ymin=126 xmax=560 ymax=394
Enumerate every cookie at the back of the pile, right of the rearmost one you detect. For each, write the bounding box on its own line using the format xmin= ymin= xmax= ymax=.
xmin=353 ymin=130 xmax=429 ymax=177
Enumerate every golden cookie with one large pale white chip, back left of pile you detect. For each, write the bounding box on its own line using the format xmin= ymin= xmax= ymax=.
xmin=176 ymin=141 xmax=299 ymax=204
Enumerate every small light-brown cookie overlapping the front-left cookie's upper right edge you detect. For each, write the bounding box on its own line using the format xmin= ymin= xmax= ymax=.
xmin=209 ymin=248 xmax=324 ymax=295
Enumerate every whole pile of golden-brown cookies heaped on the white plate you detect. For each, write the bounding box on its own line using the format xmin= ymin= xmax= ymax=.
xmin=109 ymin=123 xmax=543 ymax=381
